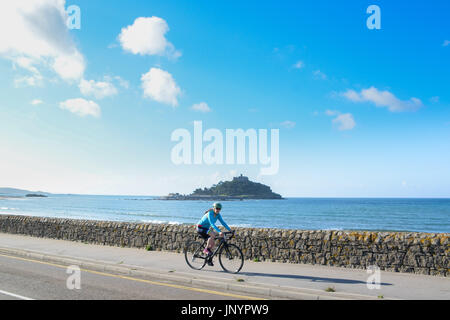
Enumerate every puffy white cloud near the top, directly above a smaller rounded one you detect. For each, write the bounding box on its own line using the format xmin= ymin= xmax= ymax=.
xmin=119 ymin=17 xmax=181 ymax=59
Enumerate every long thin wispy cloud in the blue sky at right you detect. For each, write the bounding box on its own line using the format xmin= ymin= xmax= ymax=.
xmin=342 ymin=87 xmax=423 ymax=112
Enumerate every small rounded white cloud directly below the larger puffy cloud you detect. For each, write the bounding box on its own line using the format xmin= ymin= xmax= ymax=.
xmin=141 ymin=68 xmax=181 ymax=107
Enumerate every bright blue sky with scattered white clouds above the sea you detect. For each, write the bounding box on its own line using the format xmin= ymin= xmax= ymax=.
xmin=0 ymin=0 xmax=450 ymax=197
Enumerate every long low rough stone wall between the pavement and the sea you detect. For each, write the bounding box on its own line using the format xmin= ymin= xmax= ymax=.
xmin=0 ymin=215 xmax=450 ymax=276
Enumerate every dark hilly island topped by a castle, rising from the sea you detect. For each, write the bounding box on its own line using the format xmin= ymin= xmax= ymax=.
xmin=159 ymin=174 xmax=283 ymax=200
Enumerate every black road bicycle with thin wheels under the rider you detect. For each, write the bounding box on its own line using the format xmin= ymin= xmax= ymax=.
xmin=184 ymin=232 xmax=244 ymax=273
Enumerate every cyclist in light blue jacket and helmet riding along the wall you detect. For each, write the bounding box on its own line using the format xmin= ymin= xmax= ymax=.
xmin=197 ymin=202 xmax=231 ymax=266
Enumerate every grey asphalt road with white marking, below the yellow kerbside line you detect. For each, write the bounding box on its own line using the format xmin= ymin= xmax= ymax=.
xmin=0 ymin=255 xmax=263 ymax=300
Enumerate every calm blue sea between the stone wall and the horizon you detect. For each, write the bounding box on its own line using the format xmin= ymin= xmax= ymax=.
xmin=0 ymin=195 xmax=450 ymax=233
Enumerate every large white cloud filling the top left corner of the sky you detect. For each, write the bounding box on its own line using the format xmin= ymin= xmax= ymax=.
xmin=0 ymin=0 xmax=85 ymax=82
